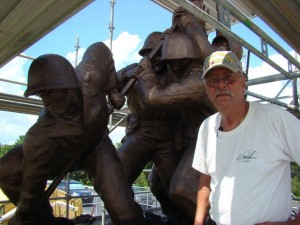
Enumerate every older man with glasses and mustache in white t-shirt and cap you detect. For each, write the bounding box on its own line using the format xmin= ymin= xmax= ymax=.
xmin=193 ymin=51 xmax=300 ymax=225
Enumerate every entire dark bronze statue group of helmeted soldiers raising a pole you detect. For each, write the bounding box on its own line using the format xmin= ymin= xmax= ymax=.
xmin=0 ymin=1 xmax=241 ymax=225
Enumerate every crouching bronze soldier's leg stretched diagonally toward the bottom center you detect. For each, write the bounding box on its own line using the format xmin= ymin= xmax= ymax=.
xmin=86 ymin=137 xmax=144 ymax=225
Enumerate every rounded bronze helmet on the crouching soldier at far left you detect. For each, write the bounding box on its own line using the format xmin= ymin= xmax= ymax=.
xmin=24 ymin=54 xmax=79 ymax=97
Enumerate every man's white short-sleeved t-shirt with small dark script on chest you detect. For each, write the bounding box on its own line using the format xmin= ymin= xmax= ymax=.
xmin=193 ymin=102 xmax=300 ymax=225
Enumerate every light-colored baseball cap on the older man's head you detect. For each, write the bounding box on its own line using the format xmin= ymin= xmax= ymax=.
xmin=202 ymin=51 xmax=243 ymax=78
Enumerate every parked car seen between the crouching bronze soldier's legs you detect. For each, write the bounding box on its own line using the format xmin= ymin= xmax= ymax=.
xmin=57 ymin=180 xmax=93 ymax=204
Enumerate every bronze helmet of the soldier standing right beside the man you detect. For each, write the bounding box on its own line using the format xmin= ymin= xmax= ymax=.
xmin=161 ymin=32 xmax=199 ymax=60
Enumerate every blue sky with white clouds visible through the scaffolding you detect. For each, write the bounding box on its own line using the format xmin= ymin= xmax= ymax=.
xmin=0 ymin=0 xmax=295 ymax=144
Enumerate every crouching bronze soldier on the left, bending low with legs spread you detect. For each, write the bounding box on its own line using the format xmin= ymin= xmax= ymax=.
xmin=0 ymin=43 xmax=144 ymax=225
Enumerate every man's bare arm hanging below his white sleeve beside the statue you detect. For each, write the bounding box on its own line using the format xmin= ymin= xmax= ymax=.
xmin=194 ymin=174 xmax=211 ymax=225
